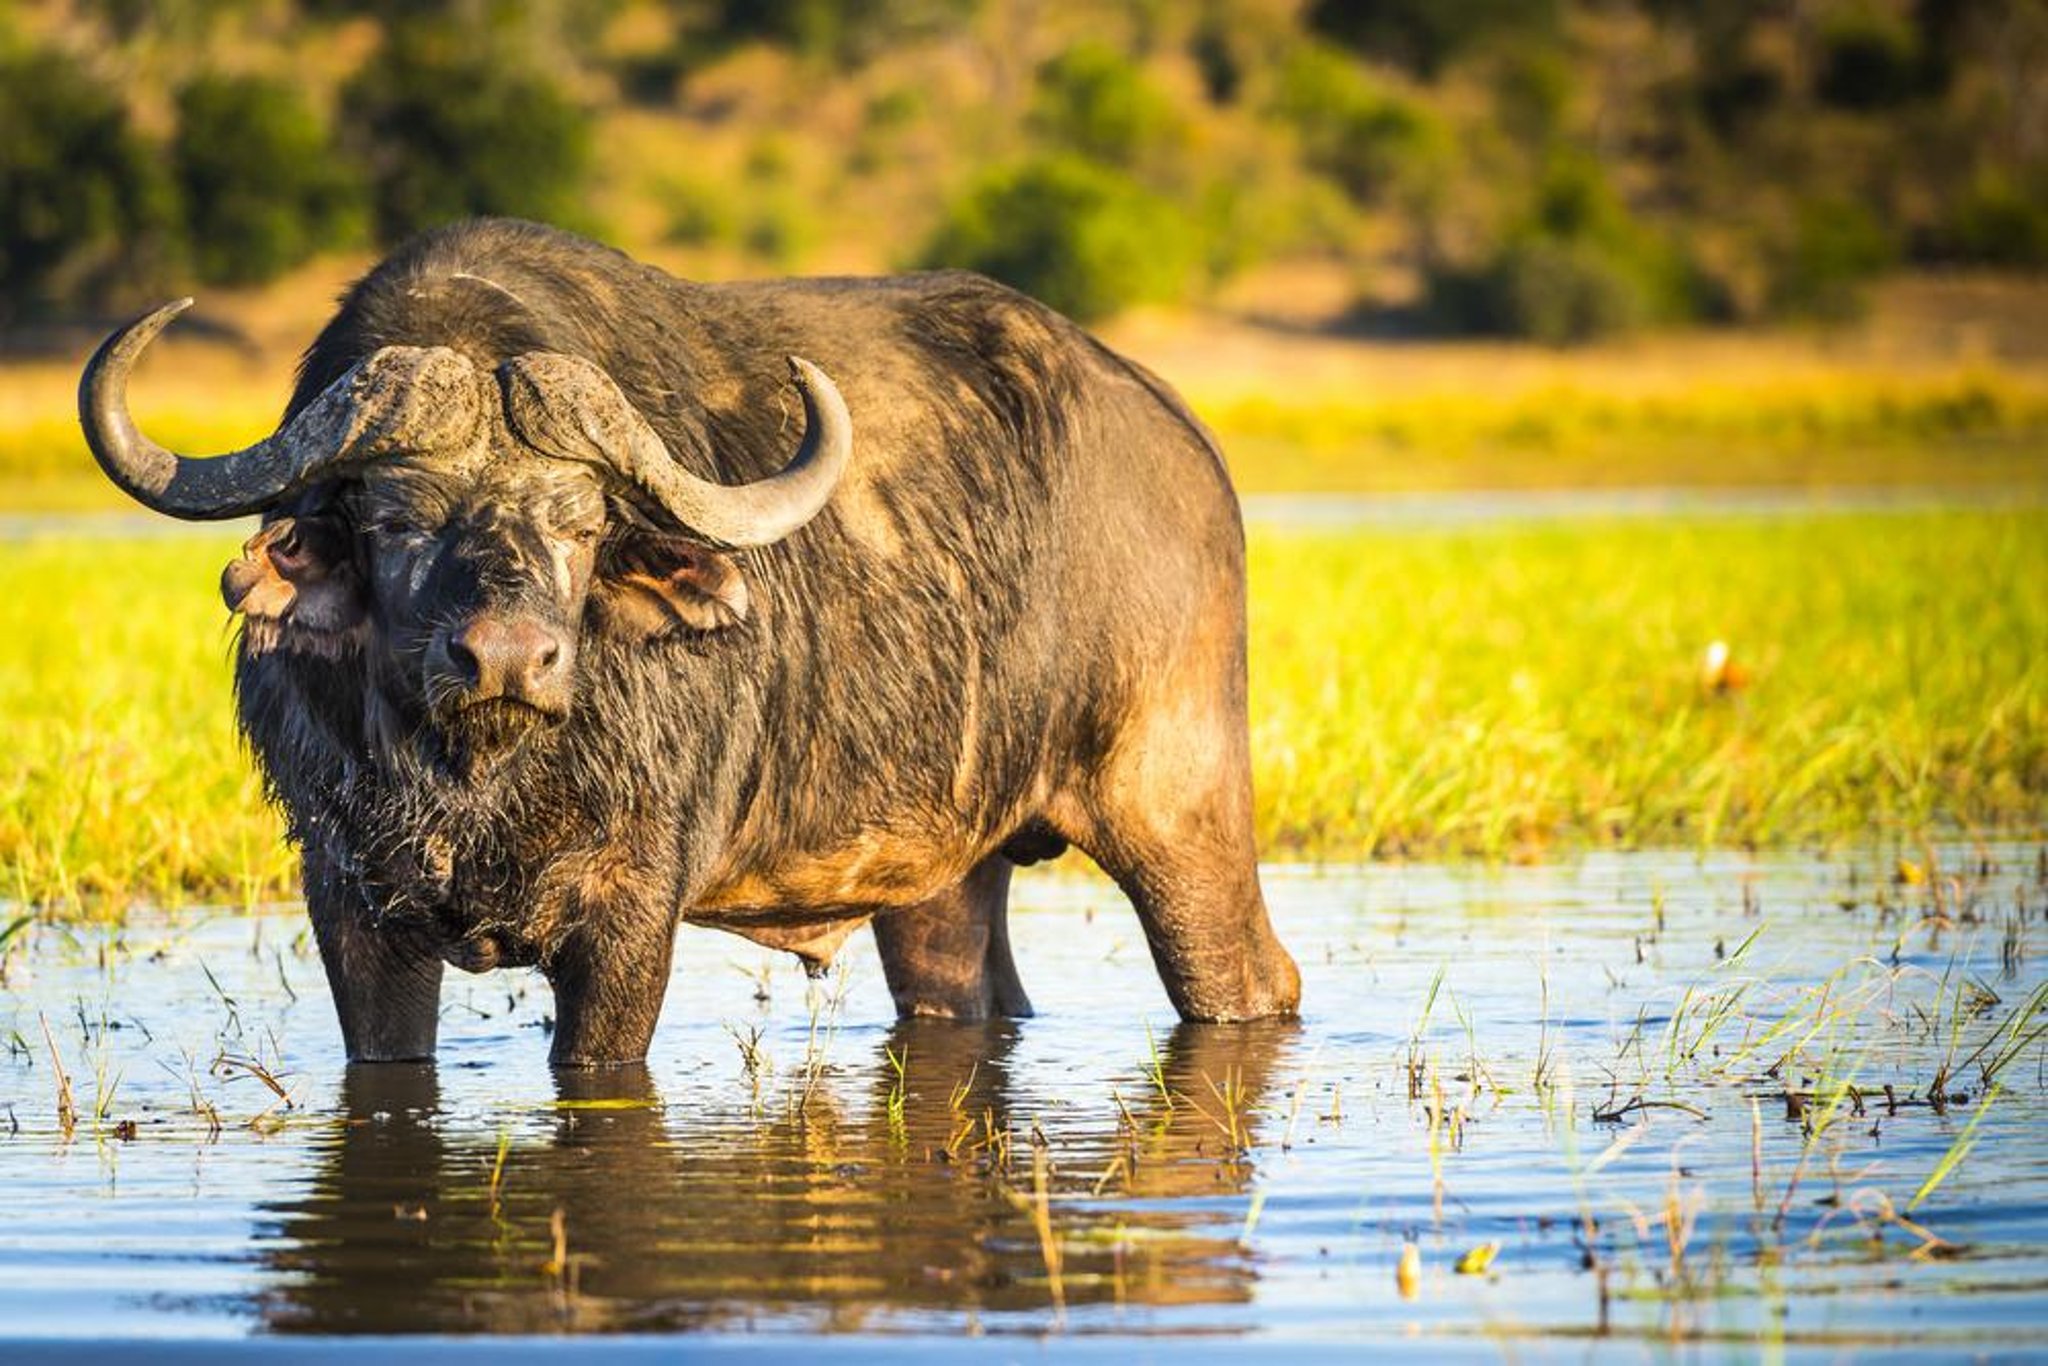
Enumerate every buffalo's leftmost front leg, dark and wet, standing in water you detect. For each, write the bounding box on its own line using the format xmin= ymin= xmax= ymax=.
xmin=305 ymin=860 xmax=440 ymax=1063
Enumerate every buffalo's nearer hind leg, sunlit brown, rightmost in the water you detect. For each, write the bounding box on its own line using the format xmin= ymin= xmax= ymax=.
xmin=1079 ymin=709 xmax=1300 ymax=1020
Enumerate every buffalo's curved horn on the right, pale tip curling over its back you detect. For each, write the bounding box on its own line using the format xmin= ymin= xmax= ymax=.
xmin=502 ymin=352 xmax=854 ymax=551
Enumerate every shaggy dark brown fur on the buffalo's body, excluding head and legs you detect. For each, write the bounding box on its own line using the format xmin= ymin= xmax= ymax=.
xmin=236 ymin=221 xmax=1243 ymax=1064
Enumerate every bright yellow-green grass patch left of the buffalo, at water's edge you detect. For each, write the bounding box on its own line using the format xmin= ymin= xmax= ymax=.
xmin=0 ymin=537 xmax=293 ymax=905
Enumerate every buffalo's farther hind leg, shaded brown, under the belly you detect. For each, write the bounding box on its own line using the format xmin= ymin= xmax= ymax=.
xmin=874 ymin=854 xmax=1030 ymax=1020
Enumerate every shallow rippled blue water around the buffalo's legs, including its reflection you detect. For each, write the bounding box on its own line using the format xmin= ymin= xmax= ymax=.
xmin=0 ymin=846 xmax=2048 ymax=1358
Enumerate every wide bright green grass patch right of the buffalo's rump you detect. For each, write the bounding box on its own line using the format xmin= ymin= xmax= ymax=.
xmin=1251 ymin=510 xmax=2048 ymax=856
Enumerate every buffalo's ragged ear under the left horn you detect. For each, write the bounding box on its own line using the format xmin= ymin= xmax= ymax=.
xmin=221 ymin=516 xmax=367 ymax=653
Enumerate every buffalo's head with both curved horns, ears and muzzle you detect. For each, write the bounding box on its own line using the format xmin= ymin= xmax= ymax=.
xmin=80 ymin=299 xmax=852 ymax=774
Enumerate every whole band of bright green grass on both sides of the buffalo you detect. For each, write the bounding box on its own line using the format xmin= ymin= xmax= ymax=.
xmin=0 ymin=510 xmax=2048 ymax=907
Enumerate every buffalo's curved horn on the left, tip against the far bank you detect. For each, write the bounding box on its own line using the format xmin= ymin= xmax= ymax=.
xmin=78 ymin=299 xmax=483 ymax=522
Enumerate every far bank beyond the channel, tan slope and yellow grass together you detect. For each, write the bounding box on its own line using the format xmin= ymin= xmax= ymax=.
xmin=0 ymin=294 xmax=2048 ymax=512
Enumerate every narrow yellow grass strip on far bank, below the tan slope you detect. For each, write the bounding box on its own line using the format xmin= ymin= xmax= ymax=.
xmin=0 ymin=369 xmax=2048 ymax=512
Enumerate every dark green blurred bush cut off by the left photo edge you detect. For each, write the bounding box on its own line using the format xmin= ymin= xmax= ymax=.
xmin=0 ymin=51 xmax=182 ymax=324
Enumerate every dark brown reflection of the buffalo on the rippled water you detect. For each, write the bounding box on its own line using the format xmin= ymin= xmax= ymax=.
xmin=260 ymin=1020 xmax=1294 ymax=1333
